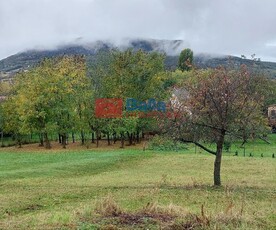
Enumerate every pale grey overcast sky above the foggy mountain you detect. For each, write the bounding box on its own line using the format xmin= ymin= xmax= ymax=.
xmin=0 ymin=0 xmax=276 ymax=62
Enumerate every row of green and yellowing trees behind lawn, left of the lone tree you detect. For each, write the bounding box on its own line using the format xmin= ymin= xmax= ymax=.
xmin=1 ymin=50 xmax=170 ymax=148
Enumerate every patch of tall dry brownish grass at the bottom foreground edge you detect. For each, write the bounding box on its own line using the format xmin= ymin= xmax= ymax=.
xmin=79 ymin=194 xmax=250 ymax=230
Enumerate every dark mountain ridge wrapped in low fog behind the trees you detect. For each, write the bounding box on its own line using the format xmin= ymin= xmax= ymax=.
xmin=0 ymin=39 xmax=276 ymax=80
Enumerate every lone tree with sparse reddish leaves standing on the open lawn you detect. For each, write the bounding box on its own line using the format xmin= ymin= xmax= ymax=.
xmin=164 ymin=65 xmax=265 ymax=186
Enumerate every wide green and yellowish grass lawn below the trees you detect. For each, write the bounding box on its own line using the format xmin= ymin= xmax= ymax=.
xmin=0 ymin=140 xmax=276 ymax=229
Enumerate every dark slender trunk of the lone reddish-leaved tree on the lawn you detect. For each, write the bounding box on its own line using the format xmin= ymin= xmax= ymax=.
xmin=214 ymin=130 xmax=225 ymax=186
